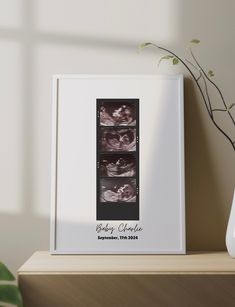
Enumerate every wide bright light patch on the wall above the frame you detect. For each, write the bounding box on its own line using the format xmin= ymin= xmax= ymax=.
xmin=35 ymin=0 xmax=179 ymax=46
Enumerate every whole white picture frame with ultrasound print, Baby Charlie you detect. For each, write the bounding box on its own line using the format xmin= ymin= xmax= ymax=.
xmin=50 ymin=75 xmax=186 ymax=254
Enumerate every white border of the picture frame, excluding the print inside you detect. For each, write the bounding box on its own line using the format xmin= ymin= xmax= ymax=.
xmin=50 ymin=74 xmax=186 ymax=255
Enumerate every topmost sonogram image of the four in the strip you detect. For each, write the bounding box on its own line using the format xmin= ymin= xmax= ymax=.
xmin=99 ymin=101 xmax=136 ymax=126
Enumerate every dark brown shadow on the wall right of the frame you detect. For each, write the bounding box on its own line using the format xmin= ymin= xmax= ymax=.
xmin=185 ymin=78 xmax=230 ymax=250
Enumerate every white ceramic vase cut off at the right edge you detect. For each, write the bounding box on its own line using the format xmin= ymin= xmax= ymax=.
xmin=226 ymin=190 xmax=235 ymax=258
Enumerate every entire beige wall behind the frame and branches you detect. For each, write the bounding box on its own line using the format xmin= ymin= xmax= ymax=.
xmin=0 ymin=0 xmax=235 ymax=271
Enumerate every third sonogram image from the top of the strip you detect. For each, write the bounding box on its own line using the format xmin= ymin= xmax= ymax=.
xmin=99 ymin=154 xmax=136 ymax=177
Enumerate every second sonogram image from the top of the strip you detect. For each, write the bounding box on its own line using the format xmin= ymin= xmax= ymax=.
xmin=100 ymin=128 xmax=136 ymax=152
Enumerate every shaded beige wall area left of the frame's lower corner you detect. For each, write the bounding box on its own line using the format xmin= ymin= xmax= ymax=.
xmin=0 ymin=211 xmax=49 ymax=274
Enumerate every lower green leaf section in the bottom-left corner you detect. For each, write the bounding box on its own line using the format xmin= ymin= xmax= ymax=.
xmin=0 ymin=285 xmax=23 ymax=307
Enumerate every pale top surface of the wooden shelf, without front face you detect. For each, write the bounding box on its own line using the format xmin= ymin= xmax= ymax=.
xmin=19 ymin=252 xmax=235 ymax=274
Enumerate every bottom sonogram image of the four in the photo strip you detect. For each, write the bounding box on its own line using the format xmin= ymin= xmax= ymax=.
xmin=100 ymin=178 xmax=136 ymax=203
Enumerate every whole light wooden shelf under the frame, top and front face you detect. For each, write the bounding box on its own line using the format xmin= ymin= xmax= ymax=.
xmin=18 ymin=252 xmax=235 ymax=307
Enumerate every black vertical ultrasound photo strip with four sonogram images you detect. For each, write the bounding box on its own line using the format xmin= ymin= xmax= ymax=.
xmin=97 ymin=99 xmax=139 ymax=220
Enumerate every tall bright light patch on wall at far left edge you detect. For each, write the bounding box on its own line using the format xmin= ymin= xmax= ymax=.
xmin=0 ymin=41 xmax=24 ymax=214
